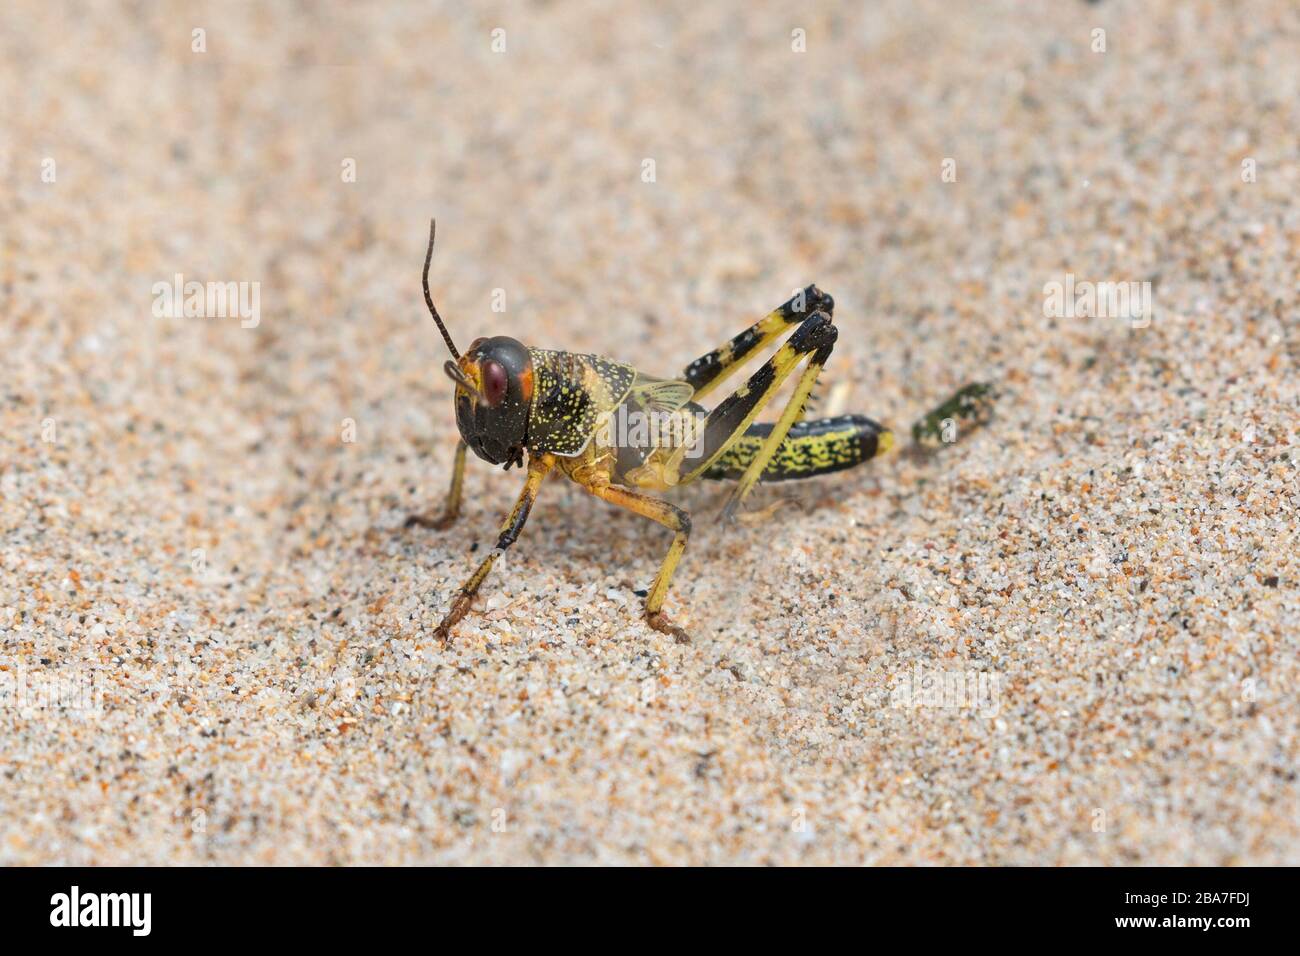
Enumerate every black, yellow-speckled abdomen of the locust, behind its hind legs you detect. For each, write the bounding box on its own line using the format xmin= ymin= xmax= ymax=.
xmin=701 ymin=415 xmax=893 ymax=481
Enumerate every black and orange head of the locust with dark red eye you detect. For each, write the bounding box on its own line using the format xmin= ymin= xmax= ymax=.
xmin=447 ymin=336 xmax=533 ymax=466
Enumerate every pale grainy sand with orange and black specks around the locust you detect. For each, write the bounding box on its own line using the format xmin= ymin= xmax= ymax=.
xmin=0 ymin=0 xmax=1300 ymax=865
